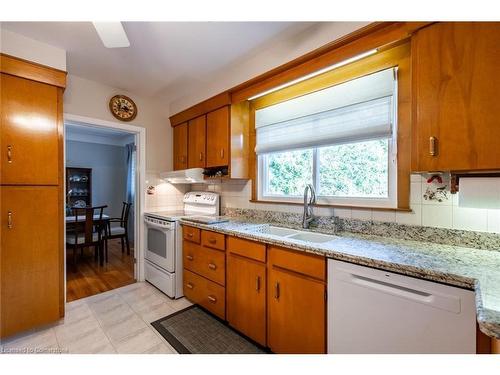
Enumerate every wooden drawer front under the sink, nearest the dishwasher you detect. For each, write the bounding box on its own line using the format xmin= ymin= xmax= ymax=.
xmin=269 ymin=246 xmax=326 ymax=281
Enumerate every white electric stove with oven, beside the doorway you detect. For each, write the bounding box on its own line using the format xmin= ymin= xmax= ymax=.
xmin=144 ymin=191 xmax=220 ymax=298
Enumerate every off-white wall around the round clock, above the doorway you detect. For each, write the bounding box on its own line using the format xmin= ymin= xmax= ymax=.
xmin=64 ymin=74 xmax=173 ymax=173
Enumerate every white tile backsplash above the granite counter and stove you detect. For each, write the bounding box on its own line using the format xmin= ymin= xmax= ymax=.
xmin=158 ymin=175 xmax=500 ymax=233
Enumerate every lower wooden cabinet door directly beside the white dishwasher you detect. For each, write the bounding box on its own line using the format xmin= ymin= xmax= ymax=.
xmin=267 ymin=267 xmax=326 ymax=353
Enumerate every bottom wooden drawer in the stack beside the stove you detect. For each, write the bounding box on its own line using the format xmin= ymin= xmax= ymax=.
xmin=183 ymin=269 xmax=226 ymax=319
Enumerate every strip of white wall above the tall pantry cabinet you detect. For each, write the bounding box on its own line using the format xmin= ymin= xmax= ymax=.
xmin=0 ymin=24 xmax=66 ymax=71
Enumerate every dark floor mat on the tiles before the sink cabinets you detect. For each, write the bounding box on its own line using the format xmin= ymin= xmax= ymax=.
xmin=151 ymin=306 xmax=266 ymax=354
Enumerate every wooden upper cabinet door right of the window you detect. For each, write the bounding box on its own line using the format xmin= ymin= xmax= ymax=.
xmin=412 ymin=22 xmax=500 ymax=171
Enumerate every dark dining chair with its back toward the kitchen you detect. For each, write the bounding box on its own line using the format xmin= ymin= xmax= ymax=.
xmin=66 ymin=206 xmax=107 ymax=270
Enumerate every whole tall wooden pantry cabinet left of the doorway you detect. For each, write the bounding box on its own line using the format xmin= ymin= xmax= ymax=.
xmin=0 ymin=54 xmax=66 ymax=338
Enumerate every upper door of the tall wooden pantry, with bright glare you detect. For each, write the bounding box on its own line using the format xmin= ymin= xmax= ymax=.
xmin=0 ymin=74 xmax=62 ymax=185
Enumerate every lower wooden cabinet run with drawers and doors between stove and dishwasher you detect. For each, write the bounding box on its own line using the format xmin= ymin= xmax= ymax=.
xmin=183 ymin=226 xmax=326 ymax=353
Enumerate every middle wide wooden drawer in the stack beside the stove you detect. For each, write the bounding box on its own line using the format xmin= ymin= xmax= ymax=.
xmin=182 ymin=241 xmax=226 ymax=285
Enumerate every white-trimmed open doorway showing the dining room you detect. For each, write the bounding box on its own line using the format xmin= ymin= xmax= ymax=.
xmin=64 ymin=114 xmax=145 ymax=302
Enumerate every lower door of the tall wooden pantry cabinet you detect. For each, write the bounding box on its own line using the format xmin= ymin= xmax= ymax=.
xmin=0 ymin=186 xmax=63 ymax=337
